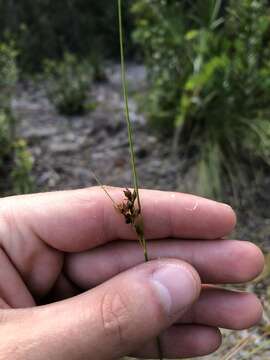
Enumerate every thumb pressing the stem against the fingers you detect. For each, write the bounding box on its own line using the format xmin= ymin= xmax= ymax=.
xmin=2 ymin=260 xmax=201 ymax=360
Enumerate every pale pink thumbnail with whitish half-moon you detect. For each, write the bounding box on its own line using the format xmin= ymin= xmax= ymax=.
xmin=153 ymin=264 xmax=199 ymax=316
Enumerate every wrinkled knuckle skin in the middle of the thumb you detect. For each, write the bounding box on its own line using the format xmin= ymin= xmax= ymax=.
xmin=101 ymin=292 xmax=132 ymax=345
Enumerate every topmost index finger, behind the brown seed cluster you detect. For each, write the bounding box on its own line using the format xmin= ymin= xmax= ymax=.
xmin=0 ymin=188 xmax=236 ymax=252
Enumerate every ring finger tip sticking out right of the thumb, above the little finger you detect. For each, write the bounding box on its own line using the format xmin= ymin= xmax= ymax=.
xmin=178 ymin=287 xmax=263 ymax=330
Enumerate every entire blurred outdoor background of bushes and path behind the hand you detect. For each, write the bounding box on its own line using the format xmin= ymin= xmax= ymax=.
xmin=0 ymin=0 xmax=270 ymax=360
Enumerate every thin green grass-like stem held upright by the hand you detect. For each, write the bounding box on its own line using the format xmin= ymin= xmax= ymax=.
xmin=118 ymin=0 xmax=163 ymax=360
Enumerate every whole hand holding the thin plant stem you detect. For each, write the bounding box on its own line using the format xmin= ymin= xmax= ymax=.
xmin=0 ymin=188 xmax=264 ymax=360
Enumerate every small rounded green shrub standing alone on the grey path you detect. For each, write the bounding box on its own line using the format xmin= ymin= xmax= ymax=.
xmin=44 ymin=53 xmax=92 ymax=115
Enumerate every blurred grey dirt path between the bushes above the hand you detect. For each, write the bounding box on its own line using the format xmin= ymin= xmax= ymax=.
xmin=14 ymin=65 xmax=176 ymax=191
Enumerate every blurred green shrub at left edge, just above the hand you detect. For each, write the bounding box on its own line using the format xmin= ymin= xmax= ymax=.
xmin=0 ymin=43 xmax=33 ymax=194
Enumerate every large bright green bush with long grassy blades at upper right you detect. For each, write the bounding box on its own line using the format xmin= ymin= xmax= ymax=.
xmin=133 ymin=0 xmax=270 ymax=197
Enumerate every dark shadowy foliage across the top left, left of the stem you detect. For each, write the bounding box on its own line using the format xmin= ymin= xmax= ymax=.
xmin=0 ymin=0 xmax=132 ymax=73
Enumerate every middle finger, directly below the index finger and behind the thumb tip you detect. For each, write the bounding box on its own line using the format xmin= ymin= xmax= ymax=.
xmin=65 ymin=240 xmax=264 ymax=289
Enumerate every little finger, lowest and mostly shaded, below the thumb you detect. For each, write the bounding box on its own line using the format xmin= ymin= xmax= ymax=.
xmin=131 ymin=325 xmax=221 ymax=359
